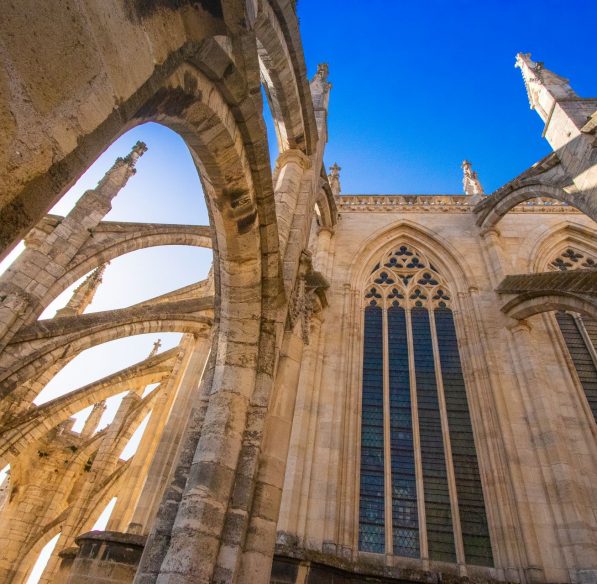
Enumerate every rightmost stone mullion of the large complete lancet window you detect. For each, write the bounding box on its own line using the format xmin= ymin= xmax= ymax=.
xmin=429 ymin=310 xmax=466 ymax=576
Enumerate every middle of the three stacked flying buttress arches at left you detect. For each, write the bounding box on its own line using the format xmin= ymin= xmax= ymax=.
xmin=2 ymin=299 xmax=212 ymax=395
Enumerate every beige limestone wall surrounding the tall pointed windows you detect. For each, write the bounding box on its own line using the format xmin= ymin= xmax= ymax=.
xmin=278 ymin=205 xmax=597 ymax=582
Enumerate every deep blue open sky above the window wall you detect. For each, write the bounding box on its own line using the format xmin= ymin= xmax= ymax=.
xmin=298 ymin=0 xmax=597 ymax=194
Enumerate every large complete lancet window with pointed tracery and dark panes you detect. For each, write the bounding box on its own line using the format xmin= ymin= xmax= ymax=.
xmin=359 ymin=245 xmax=493 ymax=566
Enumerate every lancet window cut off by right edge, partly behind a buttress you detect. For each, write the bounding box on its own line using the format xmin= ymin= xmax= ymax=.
xmin=549 ymin=247 xmax=597 ymax=422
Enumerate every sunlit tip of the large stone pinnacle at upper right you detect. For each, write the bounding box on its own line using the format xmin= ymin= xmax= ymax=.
xmin=515 ymin=53 xmax=577 ymax=123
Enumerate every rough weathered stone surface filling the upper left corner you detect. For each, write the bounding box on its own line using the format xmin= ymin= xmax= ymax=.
xmin=0 ymin=0 xmax=257 ymax=254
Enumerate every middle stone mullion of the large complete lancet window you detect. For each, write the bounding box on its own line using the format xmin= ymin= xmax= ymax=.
xmin=405 ymin=309 xmax=429 ymax=570
